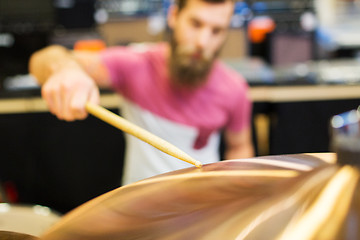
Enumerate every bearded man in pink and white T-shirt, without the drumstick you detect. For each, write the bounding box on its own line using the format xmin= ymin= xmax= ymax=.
xmin=29 ymin=0 xmax=254 ymax=185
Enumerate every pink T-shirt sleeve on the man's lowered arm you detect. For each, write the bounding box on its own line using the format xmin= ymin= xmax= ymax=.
xmin=226 ymin=79 xmax=252 ymax=132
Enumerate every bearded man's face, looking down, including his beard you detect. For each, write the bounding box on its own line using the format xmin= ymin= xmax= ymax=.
xmin=169 ymin=0 xmax=233 ymax=86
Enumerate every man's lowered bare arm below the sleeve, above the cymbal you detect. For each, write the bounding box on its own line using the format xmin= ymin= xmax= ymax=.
xmin=224 ymin=128 xmax=254 ymax=160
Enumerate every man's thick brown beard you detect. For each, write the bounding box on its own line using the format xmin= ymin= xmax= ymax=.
xmin=169 ymin=34 xmax=220 ymax=87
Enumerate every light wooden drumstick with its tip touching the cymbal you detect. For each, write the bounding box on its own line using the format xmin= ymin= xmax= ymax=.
xmin=86 ymin=102 xmax=202 ymax=168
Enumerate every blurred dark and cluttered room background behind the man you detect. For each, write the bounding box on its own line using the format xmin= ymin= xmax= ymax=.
xmin=0 ymin=0 xmax=360 ymax=213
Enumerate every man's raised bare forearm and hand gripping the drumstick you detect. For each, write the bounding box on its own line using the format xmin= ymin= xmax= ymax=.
xmin=29 ymin=46 xmax=110 ymax=121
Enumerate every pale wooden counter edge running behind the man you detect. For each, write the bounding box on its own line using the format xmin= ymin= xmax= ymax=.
xmin=0 ymin=85 xmax=360 ymax=114
